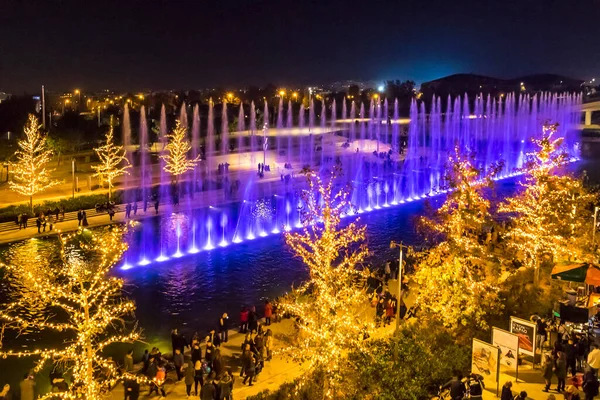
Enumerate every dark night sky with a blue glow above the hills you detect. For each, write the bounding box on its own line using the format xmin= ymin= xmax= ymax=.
xmin=0 ymin=0 xmax=600 ymax=93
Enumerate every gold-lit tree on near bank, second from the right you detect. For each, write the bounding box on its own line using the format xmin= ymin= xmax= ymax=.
xmin=414 ymin=147 xmax=503 ymax=328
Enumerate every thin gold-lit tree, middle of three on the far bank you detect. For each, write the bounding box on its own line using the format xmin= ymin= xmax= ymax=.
xmin=92 ymin=117 xmax=131 ymax=200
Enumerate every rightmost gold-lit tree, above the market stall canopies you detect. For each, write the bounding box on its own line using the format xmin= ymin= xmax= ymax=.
xmin=499 ymin=123 xmax=597 ymax=282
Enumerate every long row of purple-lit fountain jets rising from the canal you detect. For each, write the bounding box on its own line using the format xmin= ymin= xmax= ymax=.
xmin=123 ymin=94 xmax=581 ymax=265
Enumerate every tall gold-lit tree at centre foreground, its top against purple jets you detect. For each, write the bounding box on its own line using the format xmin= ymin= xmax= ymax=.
xmin=281 ymin=170 xmax=370 ymax=398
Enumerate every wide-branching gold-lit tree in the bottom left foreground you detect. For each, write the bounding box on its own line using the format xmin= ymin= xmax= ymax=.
xmin=0 ymin=228 xmax=140 ymax=400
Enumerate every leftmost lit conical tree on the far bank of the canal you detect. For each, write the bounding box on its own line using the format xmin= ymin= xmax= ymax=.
xmin=9 ymin=114 xmax=60 ymax=210
